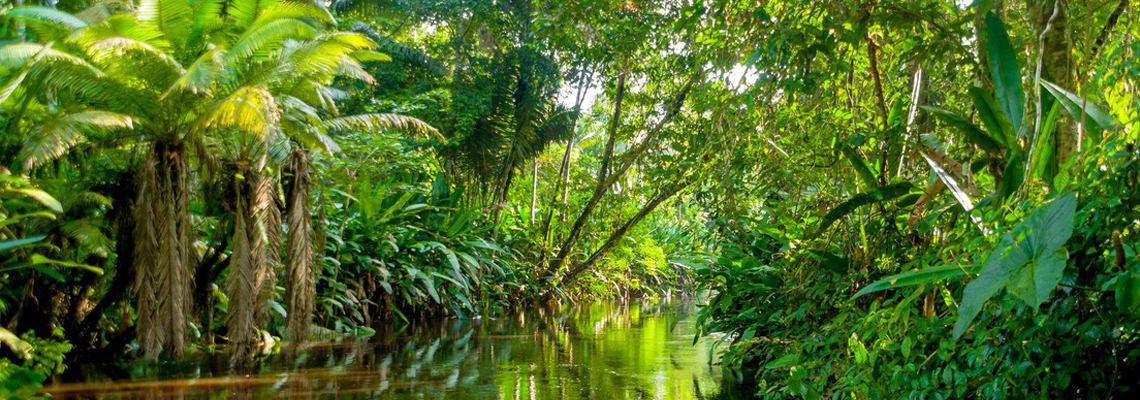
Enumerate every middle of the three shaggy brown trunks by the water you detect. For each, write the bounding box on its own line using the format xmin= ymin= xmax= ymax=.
xmin=226 ymin=161 xmax=280 ymax=367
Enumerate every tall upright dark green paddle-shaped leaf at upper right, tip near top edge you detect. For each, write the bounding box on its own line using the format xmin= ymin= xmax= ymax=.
xmin=986 ymin=11 xmax=1025 ymax=136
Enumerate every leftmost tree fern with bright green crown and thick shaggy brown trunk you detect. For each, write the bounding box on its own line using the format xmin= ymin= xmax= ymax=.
xmin=0 ymin=0 xmax=360 ymax=357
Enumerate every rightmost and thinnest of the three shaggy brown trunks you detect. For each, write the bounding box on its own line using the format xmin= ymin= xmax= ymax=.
xmin=285 ymin=150 xmax=317 ymax=344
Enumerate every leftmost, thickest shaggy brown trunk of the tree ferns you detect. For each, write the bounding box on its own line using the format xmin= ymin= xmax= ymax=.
xmin=133 ymin=141 xmax=195 ymax=358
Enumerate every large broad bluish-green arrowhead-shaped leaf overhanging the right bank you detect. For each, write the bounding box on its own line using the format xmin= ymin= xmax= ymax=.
xmin=954 ymin=193 xmax=1076 ymax=338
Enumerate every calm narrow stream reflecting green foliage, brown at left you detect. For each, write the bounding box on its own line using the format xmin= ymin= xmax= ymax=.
xmin=46 ymin=301 xmax=738 ymax=400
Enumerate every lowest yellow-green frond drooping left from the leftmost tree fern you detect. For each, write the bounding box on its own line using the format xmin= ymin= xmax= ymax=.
xmin=18 ymin=111 xmax=133 ymax=170
